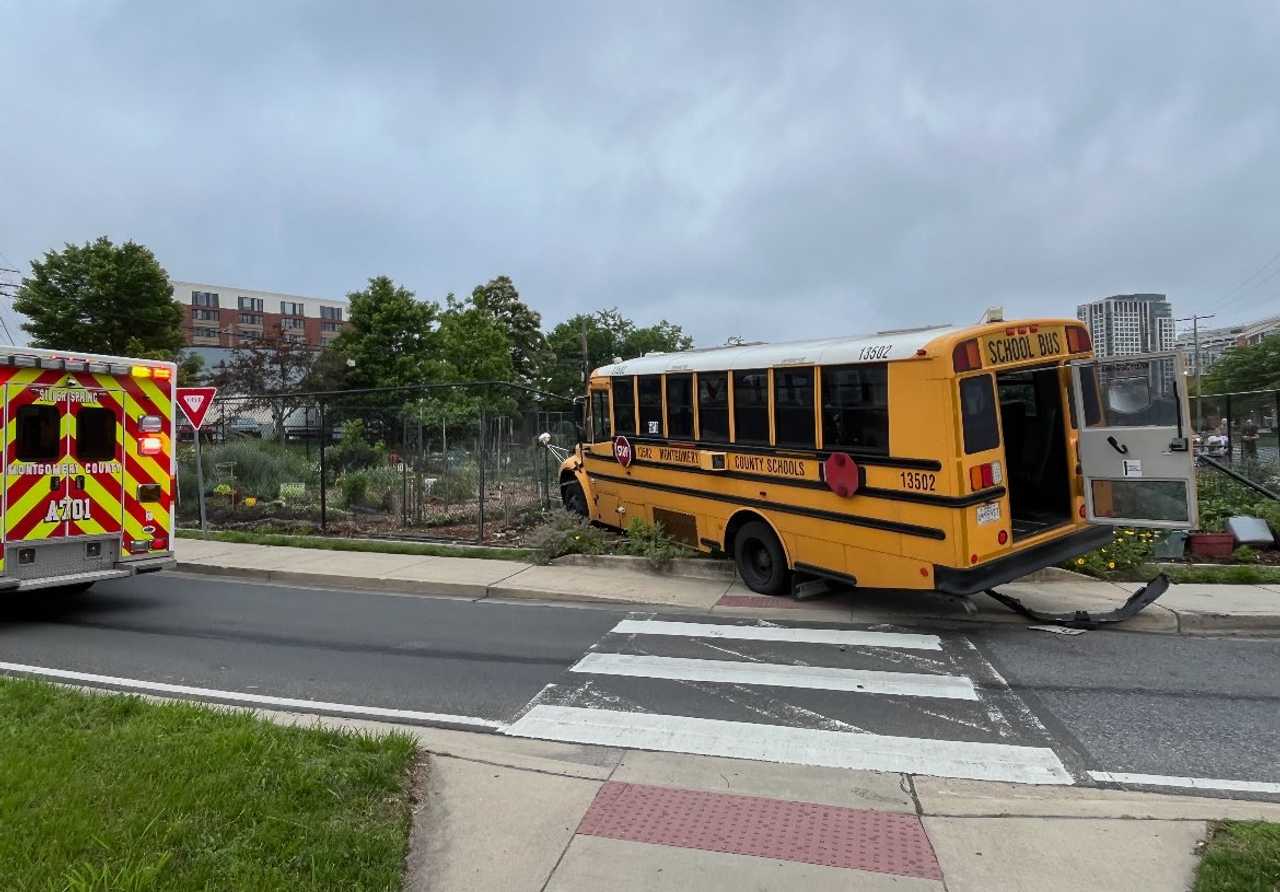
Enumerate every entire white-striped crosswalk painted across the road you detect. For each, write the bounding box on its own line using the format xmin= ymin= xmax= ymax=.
xmin=504 ymin=617 xmax=1074 ymax=784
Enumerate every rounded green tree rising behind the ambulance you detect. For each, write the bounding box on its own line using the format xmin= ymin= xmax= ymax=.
xmin=13 ymin=235 xmax=183 ymax=360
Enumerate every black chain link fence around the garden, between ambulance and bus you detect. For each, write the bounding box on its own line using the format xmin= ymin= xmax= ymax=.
xmin=178 ymin=383 xmax=577 ymax=544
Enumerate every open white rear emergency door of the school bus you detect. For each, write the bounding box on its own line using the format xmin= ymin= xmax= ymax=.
xmin=1071 ymin=352 xmax=1198 ymax=530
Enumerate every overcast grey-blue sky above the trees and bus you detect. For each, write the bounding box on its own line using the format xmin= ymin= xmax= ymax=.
xmin=0 ymin=0 xmax=1280 ymax=344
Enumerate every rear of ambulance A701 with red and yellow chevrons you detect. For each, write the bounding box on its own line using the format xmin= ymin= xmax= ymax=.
xmin=0 ymin=348 xmax=177 ymax=591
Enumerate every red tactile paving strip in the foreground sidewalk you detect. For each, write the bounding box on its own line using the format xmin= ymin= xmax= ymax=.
xmin=577 ymin=782 xmax=942 ymax=879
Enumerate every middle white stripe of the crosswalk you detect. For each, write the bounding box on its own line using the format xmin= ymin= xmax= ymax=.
xmin=570 ymin=654 xmax=978 ymax=700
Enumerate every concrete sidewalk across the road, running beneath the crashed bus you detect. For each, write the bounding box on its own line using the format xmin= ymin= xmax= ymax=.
xmin=175 ymin=539 xmax=1280 ymax=633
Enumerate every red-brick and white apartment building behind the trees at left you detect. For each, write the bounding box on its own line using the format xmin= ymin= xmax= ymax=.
xmin=173 ymin=282 xmax=348 ymax=349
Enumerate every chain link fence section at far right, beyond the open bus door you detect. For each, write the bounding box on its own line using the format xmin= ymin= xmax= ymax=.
xmin=1190 ymin=390 xmax=1280 ymax=490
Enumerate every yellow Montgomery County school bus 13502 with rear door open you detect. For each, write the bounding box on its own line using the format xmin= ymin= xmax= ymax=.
xmin=559 ymin=319 xmax=1197 ymax=594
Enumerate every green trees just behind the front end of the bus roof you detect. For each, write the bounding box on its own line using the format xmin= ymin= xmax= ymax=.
xmin=547 ymin=307 xmax=694 ymax=397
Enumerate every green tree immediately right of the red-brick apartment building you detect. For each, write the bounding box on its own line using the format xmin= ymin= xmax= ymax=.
xmin=333 ymin=275 xmax=447 ymax=388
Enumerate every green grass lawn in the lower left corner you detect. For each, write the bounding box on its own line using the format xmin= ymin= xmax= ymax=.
xmin=0 ymin=680 xmax=415 ymax=892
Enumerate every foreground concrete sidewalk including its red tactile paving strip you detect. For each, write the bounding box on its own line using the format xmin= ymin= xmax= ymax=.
xmin=247 ymin=713 xmax=1280 ymax=892
